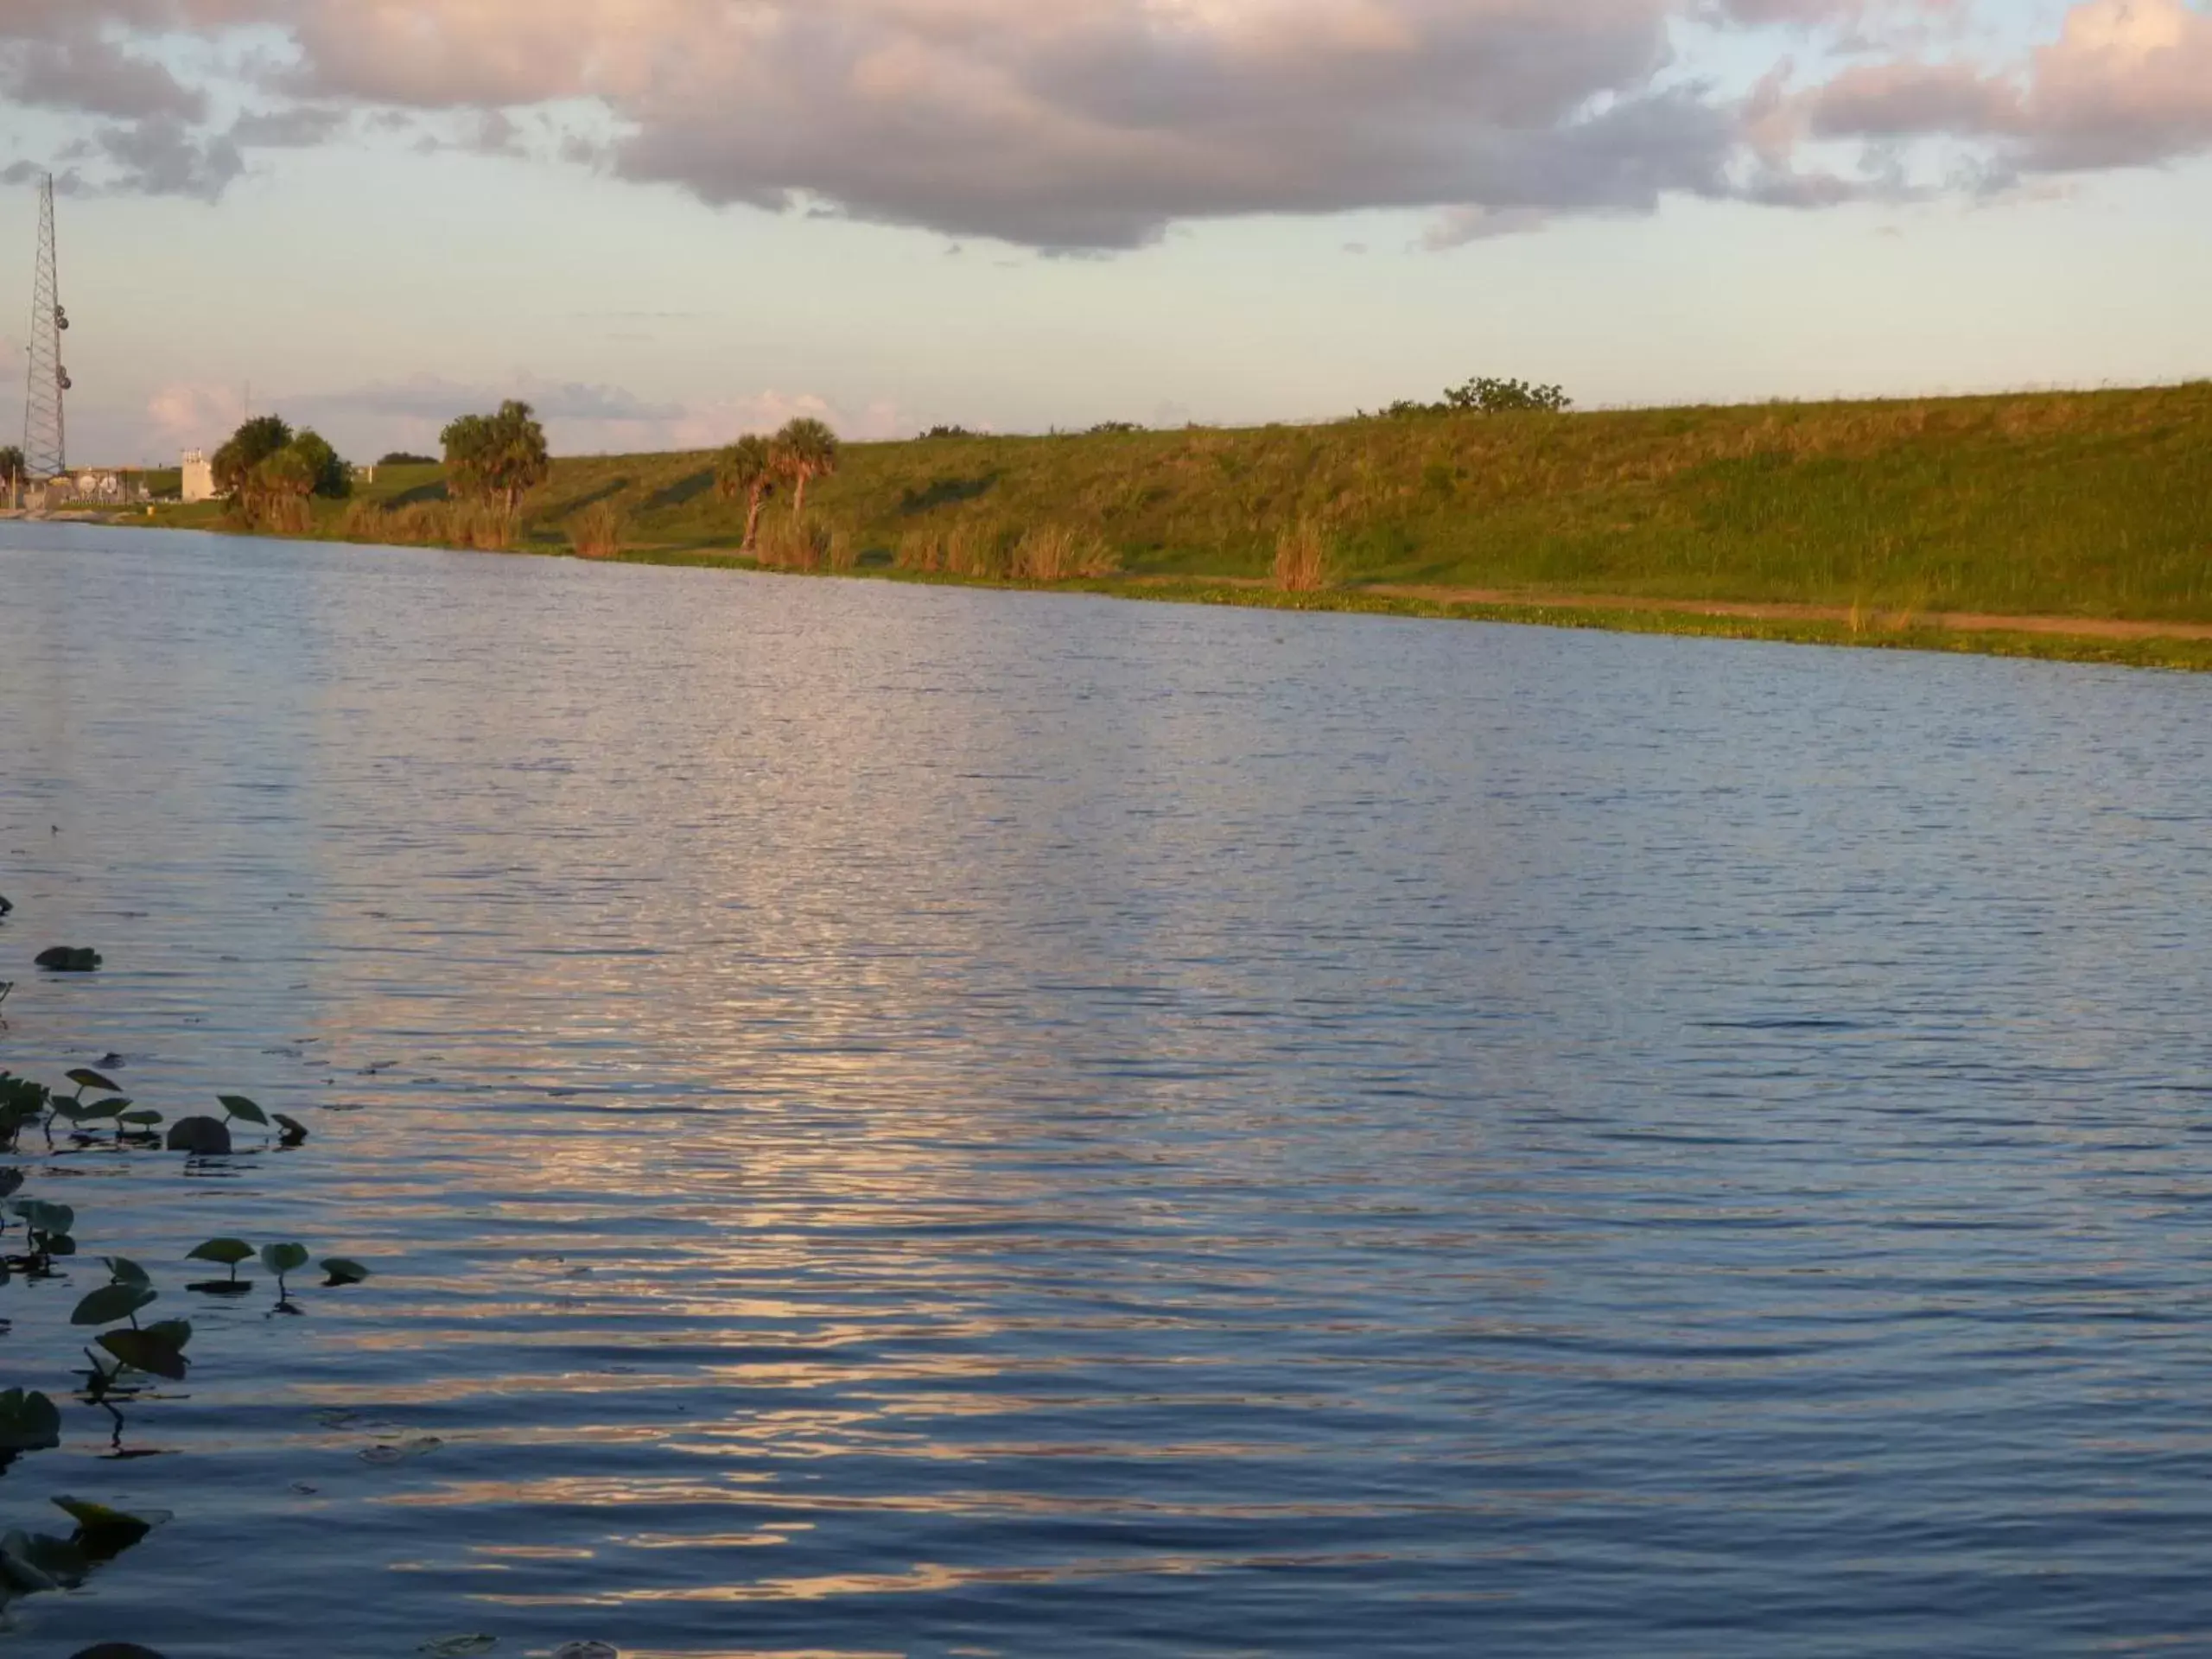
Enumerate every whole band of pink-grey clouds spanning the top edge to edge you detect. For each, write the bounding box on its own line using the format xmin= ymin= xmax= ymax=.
xmin=0 ymin=0 xmax=2212 ymax=242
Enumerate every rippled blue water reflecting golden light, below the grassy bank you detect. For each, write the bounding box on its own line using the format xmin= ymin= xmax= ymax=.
xmin=0 ymin=526 xmax=2212 ymax=1659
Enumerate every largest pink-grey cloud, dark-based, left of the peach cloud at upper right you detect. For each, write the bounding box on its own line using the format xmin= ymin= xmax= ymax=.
xmin=9 ymin=0 xmax=1778 ymax=252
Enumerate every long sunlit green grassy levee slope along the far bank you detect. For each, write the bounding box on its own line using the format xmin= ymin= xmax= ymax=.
xmin=147 ymin=383 xmax=2212 ymax=666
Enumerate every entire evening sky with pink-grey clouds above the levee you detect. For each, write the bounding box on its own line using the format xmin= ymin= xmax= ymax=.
xmin=0 ymin=0 xmax=2212 ymax=465
